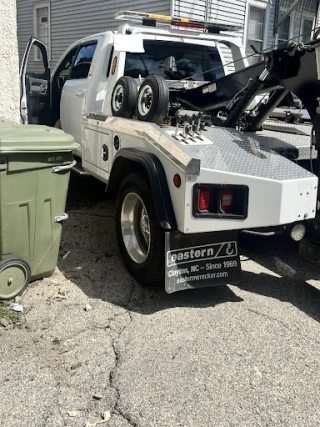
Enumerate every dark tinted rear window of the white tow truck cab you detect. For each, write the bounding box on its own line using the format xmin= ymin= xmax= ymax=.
xmin=124 ymin=40 xmax=224 ymax=81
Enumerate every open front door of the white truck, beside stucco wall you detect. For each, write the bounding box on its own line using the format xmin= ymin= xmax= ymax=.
xmin=19 ymin=37 xmax=50 ymax=124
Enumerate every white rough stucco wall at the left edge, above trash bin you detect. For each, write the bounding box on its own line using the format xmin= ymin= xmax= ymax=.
xmin=0 ymin=0 xmax=19 ymax=121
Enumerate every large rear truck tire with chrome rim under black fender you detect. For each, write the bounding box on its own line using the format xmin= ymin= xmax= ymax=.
xmin=116 ymin=174 xmax=165 ymax=284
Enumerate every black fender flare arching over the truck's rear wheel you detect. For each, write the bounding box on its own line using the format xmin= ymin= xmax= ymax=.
xmin=107 ymin=148 xmax=177 ymax=230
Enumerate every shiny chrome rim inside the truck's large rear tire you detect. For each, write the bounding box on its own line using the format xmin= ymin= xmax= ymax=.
xmin=121 ymin=193 xmax=151 ymax=264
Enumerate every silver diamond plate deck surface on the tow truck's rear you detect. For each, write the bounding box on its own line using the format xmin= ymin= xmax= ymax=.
xmin=178 ymin=127 xmax=314 ymax=181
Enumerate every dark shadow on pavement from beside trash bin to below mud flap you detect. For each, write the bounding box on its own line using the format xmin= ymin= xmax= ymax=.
xmin=58 ymin=174 xmax=242 ymax=314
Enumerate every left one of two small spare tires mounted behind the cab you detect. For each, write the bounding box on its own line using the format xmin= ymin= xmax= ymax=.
xmin=111 ymin=76 xmax=138 ymax=118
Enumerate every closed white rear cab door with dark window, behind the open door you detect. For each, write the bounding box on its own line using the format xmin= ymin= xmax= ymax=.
xmin=60 ymin=40 xmax=97 ymax=144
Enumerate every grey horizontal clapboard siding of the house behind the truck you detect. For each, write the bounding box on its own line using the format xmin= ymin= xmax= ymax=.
xmin=17 ymin=0 xmax=292 ymax=77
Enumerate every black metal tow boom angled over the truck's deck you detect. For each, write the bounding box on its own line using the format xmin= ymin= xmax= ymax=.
xmin=177 ymin=39 xmax=320 ymax=140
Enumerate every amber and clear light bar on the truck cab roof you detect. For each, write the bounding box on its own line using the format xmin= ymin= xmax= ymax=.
xmin=115 ymin=10 xmax=241 ymax=33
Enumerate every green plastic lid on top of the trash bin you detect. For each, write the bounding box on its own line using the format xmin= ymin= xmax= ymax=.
xmin=0 ymin=118 xmax=79 ymax=154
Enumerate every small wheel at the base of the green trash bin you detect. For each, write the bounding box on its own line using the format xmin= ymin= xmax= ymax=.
xmin=0 ymin=258 xmax=31 ymax=299
